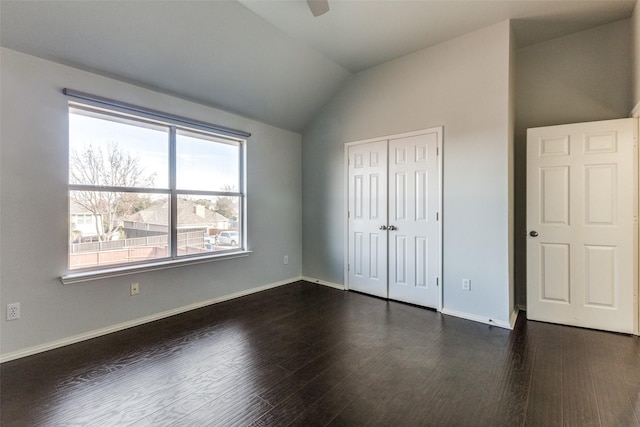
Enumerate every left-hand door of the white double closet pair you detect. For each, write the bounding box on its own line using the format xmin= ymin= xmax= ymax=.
xmin=347 ymin=140 xmax=387 ymax=298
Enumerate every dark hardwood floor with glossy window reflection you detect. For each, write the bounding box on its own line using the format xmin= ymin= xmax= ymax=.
xmin=0 ymin=282 xmax=640 ymax=426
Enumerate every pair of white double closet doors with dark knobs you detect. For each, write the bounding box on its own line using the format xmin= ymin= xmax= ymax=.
xmin=347 ymin=128 xmax=442 ymax=308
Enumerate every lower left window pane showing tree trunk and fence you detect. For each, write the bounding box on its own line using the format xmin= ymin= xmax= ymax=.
xmin=69 ymin=191 xmax=170 ymax=270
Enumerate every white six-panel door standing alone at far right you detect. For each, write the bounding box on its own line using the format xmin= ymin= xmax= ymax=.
xmin=527 ymin=119 xmax=637 ymax=333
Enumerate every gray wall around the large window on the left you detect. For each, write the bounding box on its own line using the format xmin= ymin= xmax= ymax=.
xmin=0 ymin=49 xmax=302 ymax=357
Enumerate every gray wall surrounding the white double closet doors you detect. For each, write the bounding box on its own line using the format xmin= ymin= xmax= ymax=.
xmin=302 ymin=22 xmax=512 ymax=323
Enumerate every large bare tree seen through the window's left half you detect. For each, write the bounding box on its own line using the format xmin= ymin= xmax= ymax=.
xmin=69 ymin=143 xmax=155 ymax=241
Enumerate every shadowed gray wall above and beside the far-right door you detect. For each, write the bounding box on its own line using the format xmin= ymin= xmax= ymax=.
xmin=515 ymin=20 xmax=640 ymax=306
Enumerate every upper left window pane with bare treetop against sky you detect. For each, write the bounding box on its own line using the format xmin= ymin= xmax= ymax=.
xmin=69 ymin=109 xmax=169 ymax=188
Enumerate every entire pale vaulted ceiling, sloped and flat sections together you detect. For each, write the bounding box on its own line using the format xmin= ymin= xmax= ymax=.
xmin=0 ymin=0 xmax=635 ymax=132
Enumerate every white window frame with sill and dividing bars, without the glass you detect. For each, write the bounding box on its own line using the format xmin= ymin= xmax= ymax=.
xmin=60 ymin=89 xmax=251 ymax=284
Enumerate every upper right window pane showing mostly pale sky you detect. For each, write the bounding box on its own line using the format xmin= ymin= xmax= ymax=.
xmin=176 ymin=131 xmax=240 ymax=192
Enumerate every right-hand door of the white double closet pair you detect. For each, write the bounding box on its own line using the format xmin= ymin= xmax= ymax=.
xmin=388 ymin=132 xmax=440 ymax=308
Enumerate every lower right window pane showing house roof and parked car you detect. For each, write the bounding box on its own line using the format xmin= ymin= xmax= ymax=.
xmin=178 ymin=195 xmax=242 ymax=255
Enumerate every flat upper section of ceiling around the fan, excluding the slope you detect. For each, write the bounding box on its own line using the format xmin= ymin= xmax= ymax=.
xmin=239 ymin=0 xmax=635 ymax=73
